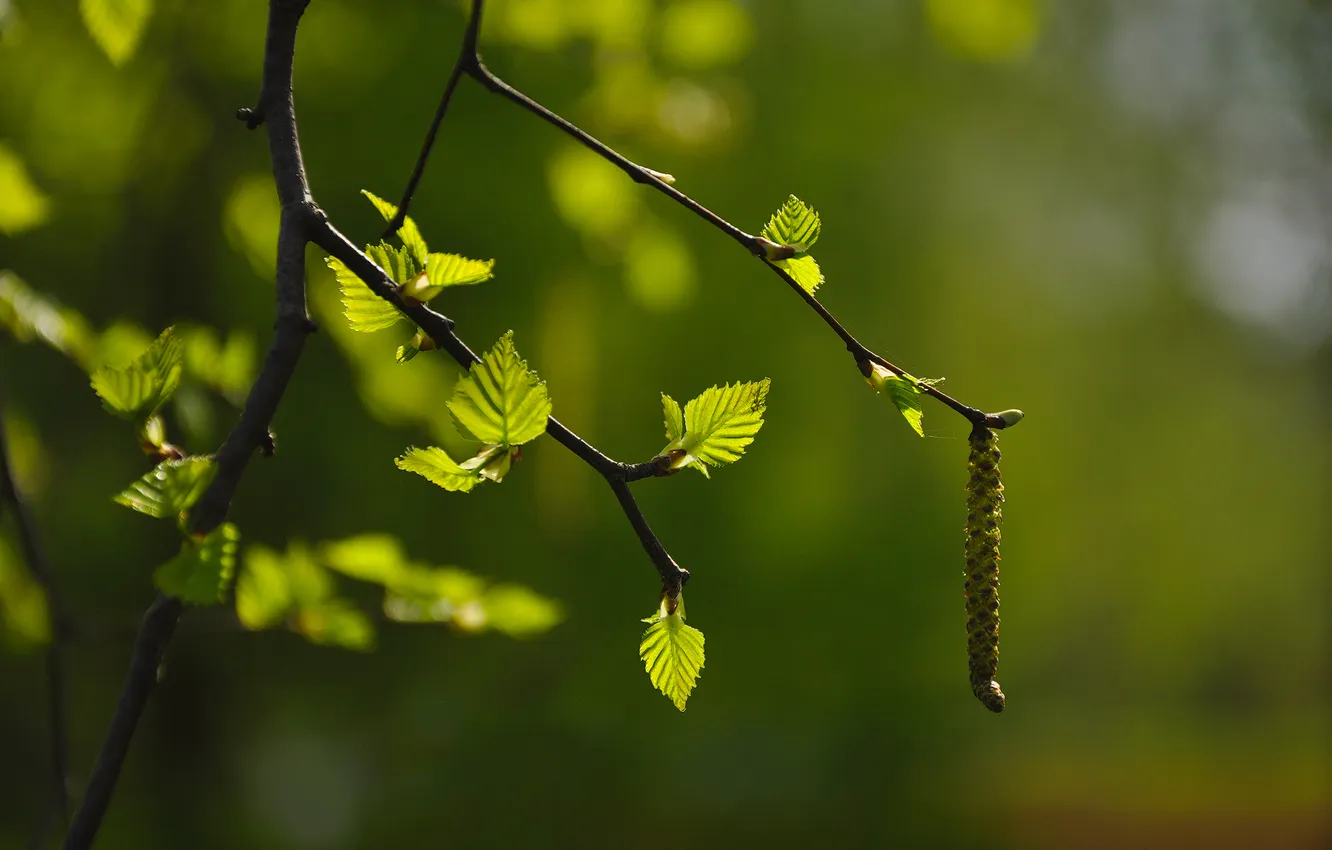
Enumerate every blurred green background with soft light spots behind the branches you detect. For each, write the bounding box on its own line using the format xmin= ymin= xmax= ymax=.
xmin=0 ymin=0 xmax=1332 ymax=850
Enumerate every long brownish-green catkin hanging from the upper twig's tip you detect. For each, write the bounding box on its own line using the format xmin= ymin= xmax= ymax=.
xmin=966 ymin=428 xmax=1004 ymax=711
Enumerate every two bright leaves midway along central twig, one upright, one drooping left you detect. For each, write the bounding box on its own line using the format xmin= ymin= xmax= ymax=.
xmin=394 ymin=330 xmax=551 ymax=492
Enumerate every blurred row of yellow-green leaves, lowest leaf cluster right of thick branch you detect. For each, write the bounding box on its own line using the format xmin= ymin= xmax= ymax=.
xmin=236 ymin=534 xmax=563 ymax=651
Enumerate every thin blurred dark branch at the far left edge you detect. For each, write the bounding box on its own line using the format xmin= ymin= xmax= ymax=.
xmin=0 ymin=408 xmax=69 ymax=847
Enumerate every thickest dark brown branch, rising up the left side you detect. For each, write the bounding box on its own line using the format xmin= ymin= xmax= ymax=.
xmin=64 ymin=0 xmax=322 ymax=850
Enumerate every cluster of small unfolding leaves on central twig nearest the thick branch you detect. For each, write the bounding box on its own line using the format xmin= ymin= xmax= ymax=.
xmin=325 ymin=191 xmax=496 ymax=362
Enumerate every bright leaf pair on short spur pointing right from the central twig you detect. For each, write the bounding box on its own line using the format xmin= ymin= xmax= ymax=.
xmin=653 ymin=378 xmax=770 ymax=477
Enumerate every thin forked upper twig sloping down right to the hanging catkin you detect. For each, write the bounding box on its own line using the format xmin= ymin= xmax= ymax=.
xmin=385 ymin=0 xmax=1010 ymax=429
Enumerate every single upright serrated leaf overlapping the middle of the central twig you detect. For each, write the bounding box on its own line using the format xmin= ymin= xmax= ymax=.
xmin=449 ymin=330 xmax=550 ymax=446
